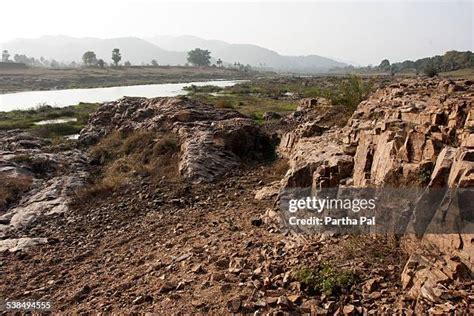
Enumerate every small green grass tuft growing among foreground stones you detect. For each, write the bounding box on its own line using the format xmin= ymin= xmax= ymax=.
xmin=294 ymin=263 xmax=358 ymax=295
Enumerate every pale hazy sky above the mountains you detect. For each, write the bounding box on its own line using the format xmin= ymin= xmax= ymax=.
xmin=0 ymin=0 xmax=474 ymax=64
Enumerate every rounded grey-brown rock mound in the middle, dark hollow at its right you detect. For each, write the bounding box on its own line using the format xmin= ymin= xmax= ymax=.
xmin=79 ymin=98 xmax=270 ymax=182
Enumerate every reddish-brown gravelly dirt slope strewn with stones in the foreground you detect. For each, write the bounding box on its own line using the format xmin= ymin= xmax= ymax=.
xmin=0 ymin=163 xmax=422 ymax=314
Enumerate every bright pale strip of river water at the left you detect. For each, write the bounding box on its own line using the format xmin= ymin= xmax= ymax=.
xmin=0 ymin=80 xmax=239 ymax=111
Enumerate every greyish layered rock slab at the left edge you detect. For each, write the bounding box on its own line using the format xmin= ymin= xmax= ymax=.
xmin=0 ymin=131 xmax=88 ymax=244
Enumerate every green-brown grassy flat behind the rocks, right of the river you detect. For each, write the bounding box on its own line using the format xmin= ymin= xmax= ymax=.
xmin=188 ymin=75 xmax=374 ymax=124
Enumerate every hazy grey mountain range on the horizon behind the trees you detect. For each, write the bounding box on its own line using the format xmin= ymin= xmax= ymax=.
xmin=2 ymin=36 xmax=347 ymax=73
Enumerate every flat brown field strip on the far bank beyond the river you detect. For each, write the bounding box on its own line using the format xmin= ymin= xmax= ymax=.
xmin=0 ymin=66 xmax=262 ymax=93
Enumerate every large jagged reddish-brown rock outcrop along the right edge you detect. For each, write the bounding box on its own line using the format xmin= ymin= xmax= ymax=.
xmin=279 ymin=79 xmax=474 ymax=302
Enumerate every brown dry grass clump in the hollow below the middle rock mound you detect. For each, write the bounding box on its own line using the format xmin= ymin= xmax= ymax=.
xmin=73 ymin=131 xmax=180 ymax=203
